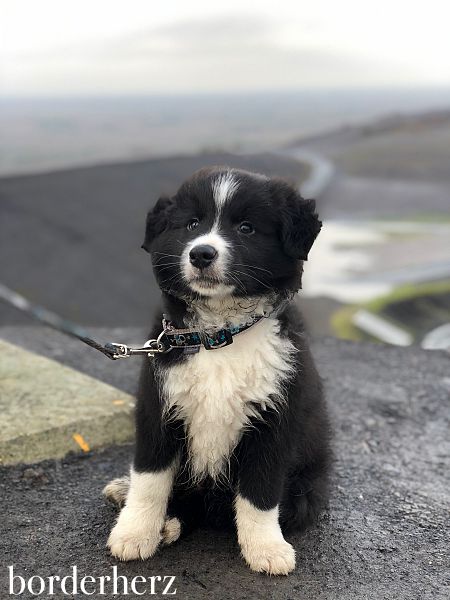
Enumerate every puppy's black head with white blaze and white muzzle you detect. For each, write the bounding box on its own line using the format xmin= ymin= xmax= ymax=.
xmin=142 ymin=167 xmax=322 ymax=297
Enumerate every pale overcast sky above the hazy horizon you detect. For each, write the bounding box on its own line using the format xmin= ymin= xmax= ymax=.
xmin=0 ymin=0 xmax=450 ymax=95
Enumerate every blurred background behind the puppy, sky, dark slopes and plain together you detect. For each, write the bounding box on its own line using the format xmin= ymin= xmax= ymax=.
xmin=0 ymin=0 xmax=450 ymax=348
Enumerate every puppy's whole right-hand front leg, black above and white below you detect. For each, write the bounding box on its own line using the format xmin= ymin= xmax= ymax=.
xmin=234 ymin=425 xmax=295 ymax=575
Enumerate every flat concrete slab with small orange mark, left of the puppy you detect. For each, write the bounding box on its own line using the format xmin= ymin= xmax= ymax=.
xmin=0 ymin=340 xmax=134 ymax=465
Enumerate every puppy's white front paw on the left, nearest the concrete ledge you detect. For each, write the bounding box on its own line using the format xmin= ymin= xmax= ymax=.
xmin=108 ymin=507 xmax=163 ymax=560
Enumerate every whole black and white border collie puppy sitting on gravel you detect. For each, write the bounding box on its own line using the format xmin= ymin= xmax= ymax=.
xmin=105 ymin=167 xmax=330 ymax=575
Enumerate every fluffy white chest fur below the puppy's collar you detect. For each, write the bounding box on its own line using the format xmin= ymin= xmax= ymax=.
xmin=162 ymin=319 xmax=296 ymax=478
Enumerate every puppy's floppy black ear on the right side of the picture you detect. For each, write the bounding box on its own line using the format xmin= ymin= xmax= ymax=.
xmin=270 ymin=179 xmax=322 ymax=260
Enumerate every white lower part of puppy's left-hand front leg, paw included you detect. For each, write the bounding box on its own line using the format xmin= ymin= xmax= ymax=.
xmin=108 ymin=461 xmax=176 ymax=560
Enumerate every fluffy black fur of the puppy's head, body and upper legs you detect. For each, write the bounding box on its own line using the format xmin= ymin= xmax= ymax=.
xmin=118 ymin=168 xmax=330 ymax=532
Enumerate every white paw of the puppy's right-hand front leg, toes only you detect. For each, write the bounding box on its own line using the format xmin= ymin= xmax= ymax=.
xmin=241 ymin=540 xmax=295 ymax=575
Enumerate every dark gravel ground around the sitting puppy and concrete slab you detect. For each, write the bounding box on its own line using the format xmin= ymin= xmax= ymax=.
xmin=0 ymin=336 xmax=450 ymax=600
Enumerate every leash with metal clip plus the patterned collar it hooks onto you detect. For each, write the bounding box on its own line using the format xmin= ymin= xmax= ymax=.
xmin=0 ymin=283 xmax=264 ymax=360
